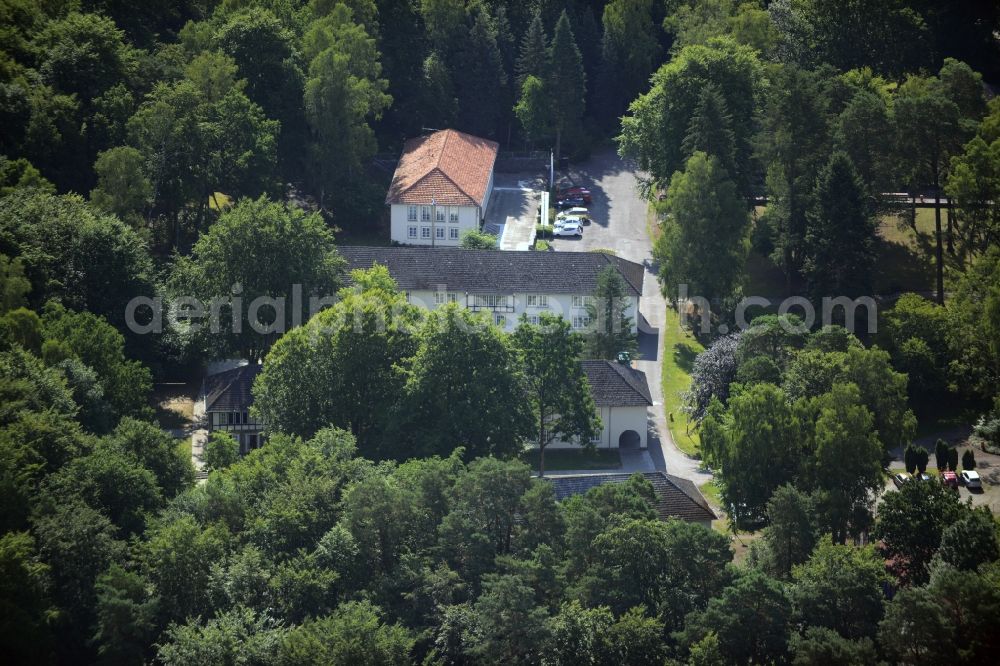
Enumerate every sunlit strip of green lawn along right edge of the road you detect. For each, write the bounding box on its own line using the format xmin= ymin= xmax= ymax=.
xmin=662 ymin=306 xmax=704 ymax=456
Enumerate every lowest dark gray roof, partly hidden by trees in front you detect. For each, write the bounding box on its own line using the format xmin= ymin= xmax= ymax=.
xmin=545 ymin=471 xmax=717 ymax=522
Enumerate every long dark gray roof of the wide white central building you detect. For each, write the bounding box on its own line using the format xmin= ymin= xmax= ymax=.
xmin=339 ymin=245 xmax=645 ymax=296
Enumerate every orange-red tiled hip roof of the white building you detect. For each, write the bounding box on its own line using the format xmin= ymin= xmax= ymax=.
xmin=385 ymin=129 xmax=499 ymax=207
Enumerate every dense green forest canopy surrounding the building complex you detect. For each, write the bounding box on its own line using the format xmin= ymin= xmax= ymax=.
xmin=0 ymin=0 xmax=1000 ymax=665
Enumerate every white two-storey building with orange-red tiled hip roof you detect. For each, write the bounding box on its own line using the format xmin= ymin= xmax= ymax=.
xmin=385 ymin=129 xmax=499 ymax=247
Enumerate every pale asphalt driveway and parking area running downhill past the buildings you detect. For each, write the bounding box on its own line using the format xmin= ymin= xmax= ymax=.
xmin=553 ymin=150 xmax=711 ymax=485
